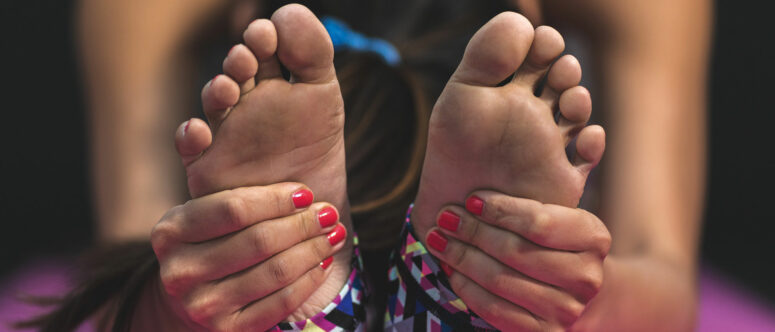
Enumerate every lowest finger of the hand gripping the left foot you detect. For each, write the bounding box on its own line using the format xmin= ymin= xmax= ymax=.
xmin=230 ymin=255 xmax=342 ymax=331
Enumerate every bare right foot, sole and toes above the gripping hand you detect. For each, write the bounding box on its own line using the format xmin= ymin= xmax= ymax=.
xmin=412 ymin=12 xmax=605 ymax=239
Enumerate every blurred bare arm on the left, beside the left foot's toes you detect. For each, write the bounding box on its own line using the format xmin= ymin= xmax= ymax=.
xmin=77 ymin=0 xmax=250 ymax=242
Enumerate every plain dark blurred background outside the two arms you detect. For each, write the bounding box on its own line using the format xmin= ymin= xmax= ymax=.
xmin=0 ymin=0 xmax=775 ymax=304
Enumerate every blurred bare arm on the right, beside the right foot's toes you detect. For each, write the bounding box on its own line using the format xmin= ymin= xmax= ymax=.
xmin=545 ymin=0 xmax=711 ymax=331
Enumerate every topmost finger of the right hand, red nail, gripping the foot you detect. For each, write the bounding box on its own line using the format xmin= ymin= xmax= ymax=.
xmin=466 ymin=190 xmax=611 ymax=257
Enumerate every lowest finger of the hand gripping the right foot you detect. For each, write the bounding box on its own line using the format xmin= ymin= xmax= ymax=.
xmin=442 ymin=262 xmax=544 ymax=331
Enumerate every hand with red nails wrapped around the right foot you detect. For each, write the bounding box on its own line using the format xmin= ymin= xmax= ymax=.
xmin=426 ymin=191 xmax=611 ymax=331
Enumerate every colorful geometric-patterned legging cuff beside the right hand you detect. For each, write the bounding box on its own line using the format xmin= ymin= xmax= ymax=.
xmin=385 ymin=206 xmax=497 ymax=332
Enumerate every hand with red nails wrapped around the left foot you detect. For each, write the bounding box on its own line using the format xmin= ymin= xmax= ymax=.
xmin=151 ymin=183 xmax=346 ymax=331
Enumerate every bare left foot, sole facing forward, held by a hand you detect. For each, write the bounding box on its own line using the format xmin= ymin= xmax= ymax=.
xmin=176 ymin=5 xmax=352 ymax=321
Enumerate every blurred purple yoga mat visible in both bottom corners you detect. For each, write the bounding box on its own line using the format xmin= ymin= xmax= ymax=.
xmin=0 ymin=259 xmax=775 ymax=332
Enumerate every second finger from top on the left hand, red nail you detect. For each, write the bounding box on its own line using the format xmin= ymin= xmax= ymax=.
xmin=166 ymin=203 xmax=344 ymax=280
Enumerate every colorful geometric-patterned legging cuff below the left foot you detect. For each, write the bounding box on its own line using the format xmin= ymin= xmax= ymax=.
xmin=269 ymin=236 xmax=366 ymax=332
